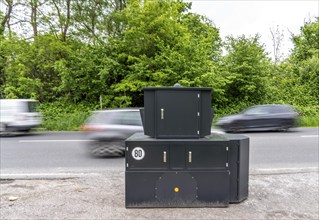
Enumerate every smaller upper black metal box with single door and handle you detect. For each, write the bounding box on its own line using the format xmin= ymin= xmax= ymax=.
xmin=143 ymin=87 xmax=213 ymax=138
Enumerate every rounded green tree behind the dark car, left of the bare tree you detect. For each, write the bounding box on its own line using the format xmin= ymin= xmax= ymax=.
xmin=223 ymin=35 xmax=270 ymax=105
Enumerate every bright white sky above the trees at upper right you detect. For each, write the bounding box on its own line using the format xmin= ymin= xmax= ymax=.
xmin=188 ymin=0 xmax=319 ymax=59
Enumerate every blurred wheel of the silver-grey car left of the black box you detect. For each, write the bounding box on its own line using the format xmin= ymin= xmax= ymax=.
xmin=90 ymin=141 xmax=125 ymax=157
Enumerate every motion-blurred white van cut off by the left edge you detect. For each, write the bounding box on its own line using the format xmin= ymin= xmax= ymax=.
xmin=0 ymin=99 xmax=42 ymax=134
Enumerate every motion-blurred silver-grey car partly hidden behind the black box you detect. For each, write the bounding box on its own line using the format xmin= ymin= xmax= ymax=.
xmin=81 ymin=109 xmax=143 ymax=157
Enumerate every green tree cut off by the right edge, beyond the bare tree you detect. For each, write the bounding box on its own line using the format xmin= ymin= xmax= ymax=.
xmin=266 ymin=18 xmax=319 ymax=117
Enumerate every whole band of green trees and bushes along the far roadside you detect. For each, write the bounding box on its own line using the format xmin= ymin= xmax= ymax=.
xmin=0 ymin=0 xmax=319 ymax=129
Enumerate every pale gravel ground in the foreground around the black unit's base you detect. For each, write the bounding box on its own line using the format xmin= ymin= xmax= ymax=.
xmin=0 ymin=171 xmax=319 ymax=219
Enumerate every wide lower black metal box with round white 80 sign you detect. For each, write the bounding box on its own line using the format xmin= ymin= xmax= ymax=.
xmin=125 ymin=133 xmax=249 ymax=208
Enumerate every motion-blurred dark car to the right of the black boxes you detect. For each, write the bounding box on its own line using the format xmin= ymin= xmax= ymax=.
xmin=216 ymin=104 xmax=299 ymax=132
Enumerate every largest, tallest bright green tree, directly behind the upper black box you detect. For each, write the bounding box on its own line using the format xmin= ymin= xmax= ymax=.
xmin=104 ymin=0 xmax=221 ymax=106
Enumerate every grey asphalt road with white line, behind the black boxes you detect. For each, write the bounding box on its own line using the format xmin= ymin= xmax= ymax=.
xmin=0 ymin=128 xmax=319 ymax=175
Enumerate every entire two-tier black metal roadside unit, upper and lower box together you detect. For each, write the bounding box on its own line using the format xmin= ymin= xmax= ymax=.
xmin=125 ymin=87 xmax=249 ymax=208
